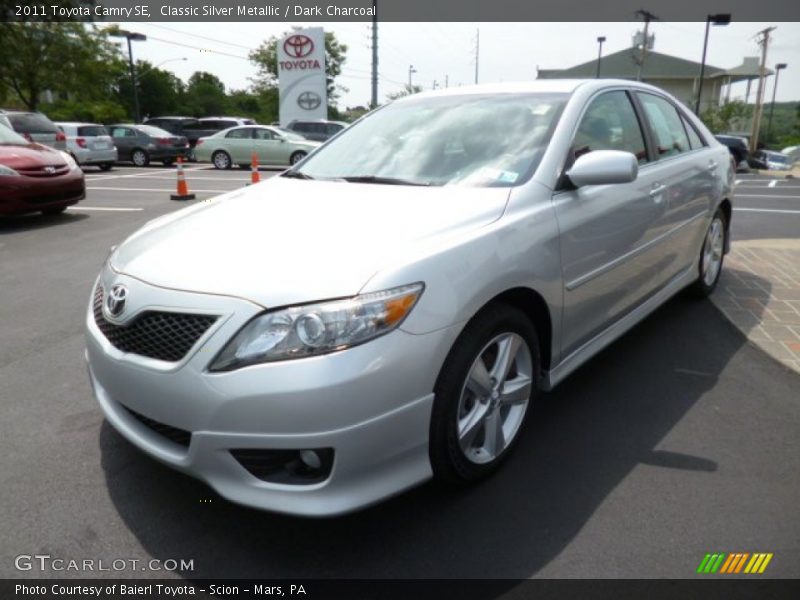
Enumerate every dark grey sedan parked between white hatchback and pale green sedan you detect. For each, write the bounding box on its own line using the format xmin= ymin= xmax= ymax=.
xmin=107 ymin=123 xmax=189 ymax=167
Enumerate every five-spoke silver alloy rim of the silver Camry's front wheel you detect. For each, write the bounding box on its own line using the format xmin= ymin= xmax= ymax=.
xmin=456 ymin=332 xmax=533 ymax=464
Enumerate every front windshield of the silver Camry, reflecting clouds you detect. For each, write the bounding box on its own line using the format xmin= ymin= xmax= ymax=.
xmin=287 ymin=94 xmax=567 ymax=187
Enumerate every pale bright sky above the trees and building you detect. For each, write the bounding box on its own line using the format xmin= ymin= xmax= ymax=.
xmin=111 ymin=21 xmax=800 ymax=108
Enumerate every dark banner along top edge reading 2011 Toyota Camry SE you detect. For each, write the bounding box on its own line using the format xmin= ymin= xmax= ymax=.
xmin=0 ymin=0 xmax=800 ymax=23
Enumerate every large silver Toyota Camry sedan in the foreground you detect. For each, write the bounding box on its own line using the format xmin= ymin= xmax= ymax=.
xmin=86 ymin=80 xmax=734 ymax=515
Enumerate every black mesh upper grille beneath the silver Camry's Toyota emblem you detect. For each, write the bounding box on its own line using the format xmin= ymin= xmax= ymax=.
xmin=93 ymin=285 xmax=217 ymax=362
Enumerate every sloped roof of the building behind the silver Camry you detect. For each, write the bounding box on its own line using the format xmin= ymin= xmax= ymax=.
xmin=538 ymin=48 xmax=725 ymax=79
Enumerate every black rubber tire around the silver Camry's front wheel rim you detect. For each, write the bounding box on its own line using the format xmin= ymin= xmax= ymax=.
xmin=429 ymin=304 xmax=540 ymax=485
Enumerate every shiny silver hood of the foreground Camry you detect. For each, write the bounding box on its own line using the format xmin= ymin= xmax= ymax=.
xmin=110 ymin=177 xmax=509 ymax=307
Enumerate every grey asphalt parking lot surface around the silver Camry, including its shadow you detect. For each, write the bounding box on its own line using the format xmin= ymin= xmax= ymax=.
xmin=0 ymin=165 xmax=800 ymax=578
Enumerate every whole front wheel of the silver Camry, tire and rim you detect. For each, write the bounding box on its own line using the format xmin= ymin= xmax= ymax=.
xmin=429 ymin=305 xmax=539 ymax=484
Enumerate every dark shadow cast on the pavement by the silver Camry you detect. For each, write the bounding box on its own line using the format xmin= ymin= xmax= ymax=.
xmin=99 ymin=294 xmax=764 ymax=585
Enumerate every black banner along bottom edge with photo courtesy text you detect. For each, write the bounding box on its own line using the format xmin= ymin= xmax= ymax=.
xmin=0 ymin=576 xmax=800 ymax=600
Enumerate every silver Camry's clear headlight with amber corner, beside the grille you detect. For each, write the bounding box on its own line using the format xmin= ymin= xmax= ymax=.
xmin=211 ymin=283 xmax=424 ymax=371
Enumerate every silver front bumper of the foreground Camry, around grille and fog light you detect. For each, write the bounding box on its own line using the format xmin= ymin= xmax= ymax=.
xmin=86 ymin=275 xmax=458 ymax=516
